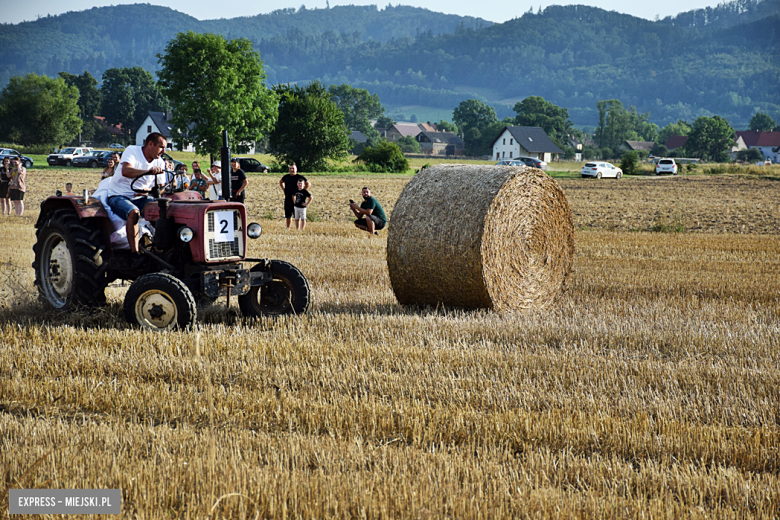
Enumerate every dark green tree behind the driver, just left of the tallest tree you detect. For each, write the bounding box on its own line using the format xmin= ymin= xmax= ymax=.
xmin=100 ymin=67 xmax=168 ymax=135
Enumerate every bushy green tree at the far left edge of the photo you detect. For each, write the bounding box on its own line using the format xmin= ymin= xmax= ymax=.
xmin=0 ymin=73 xmax=81 ymax=146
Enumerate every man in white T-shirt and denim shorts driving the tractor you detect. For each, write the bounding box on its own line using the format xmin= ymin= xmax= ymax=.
xmin=108 ymin=132 xmax=167 ymax=253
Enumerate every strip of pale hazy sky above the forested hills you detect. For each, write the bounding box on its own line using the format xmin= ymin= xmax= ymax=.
xmin=6 ymin=0 xmax=718 ymax=23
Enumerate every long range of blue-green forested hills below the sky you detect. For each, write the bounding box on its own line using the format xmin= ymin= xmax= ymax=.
xmin=0 ymin=0 xmax=780 ymax=126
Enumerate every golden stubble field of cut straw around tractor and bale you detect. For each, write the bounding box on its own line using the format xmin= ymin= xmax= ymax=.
xmin=0 ymin=170 xmax=780 ymax=518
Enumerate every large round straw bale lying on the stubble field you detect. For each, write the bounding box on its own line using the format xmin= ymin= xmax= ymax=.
xmin=387 ymin=164 xmax=574 ymax=311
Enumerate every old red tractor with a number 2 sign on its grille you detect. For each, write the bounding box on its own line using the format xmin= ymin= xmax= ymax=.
xmin=33 ymin=133 xmax=311 ymax=331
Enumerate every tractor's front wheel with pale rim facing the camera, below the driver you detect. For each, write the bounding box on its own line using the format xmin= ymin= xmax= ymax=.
xmin=124 ymin=273 xmax=198 ymax=332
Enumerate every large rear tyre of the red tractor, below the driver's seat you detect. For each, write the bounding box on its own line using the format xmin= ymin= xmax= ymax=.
xmin=33 ymin=208 xmax=109 ymax=310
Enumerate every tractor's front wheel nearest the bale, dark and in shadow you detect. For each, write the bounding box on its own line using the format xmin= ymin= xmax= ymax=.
xmin=238 ymin=260 xmax=311 ymax=317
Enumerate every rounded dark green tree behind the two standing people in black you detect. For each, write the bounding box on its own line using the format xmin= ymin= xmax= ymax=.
xmin=268 ymin=81 xmax=350 ymax=172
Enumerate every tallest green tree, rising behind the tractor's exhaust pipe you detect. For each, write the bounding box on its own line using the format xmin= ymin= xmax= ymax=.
xmin=157 ymin=31 xmax=278 ymax=156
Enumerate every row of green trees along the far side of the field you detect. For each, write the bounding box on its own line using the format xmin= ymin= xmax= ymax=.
xmin=0 ymin=31 xmax=776 ymax=170
